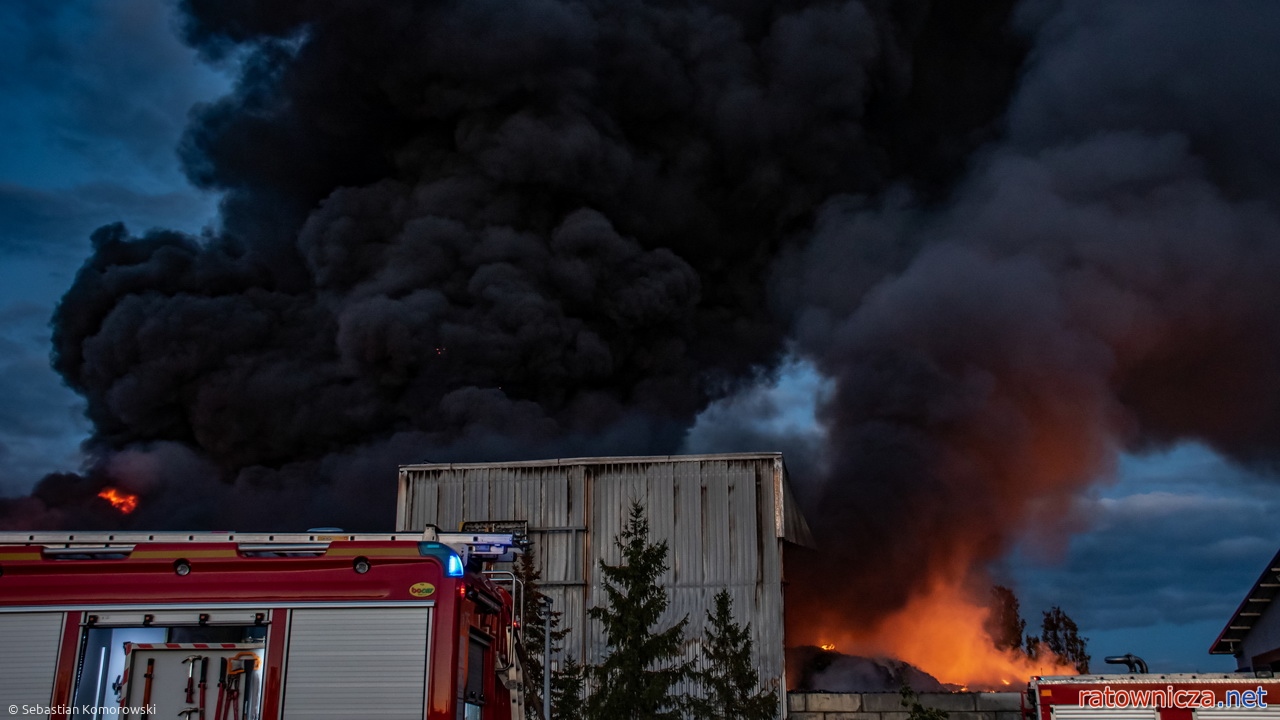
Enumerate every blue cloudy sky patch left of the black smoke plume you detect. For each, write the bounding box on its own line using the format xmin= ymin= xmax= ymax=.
xmin=0 ymin=0 xmax=228 ymax=491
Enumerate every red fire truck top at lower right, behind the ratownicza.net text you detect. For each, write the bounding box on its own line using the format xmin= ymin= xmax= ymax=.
xmin=1025 ymin=673 xmax=1280 ymax=720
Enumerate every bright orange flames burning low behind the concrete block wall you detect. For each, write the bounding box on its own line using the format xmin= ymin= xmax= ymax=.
xmin=814 ymin=576 xmax=1076 ymax=691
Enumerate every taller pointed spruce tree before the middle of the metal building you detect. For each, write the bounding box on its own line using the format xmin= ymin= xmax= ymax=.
xmin=586 ymin=502 xmax=690 ymax=720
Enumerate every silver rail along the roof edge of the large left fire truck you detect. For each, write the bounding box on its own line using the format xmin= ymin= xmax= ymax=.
xmin=0 ymin=525 xmax=521 ymax=562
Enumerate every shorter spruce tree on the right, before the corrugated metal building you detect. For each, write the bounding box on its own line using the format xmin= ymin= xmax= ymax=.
xmin=689 ymin=591 xmax=778 ymax=720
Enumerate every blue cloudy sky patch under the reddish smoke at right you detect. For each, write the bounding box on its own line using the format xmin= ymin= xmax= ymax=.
xmin=1006 ymin=447 xmax=1280 ymax=635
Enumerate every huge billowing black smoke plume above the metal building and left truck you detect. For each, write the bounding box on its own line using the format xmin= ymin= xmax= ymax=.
xmin=6 ymin=0 xmax=1021 ymax=528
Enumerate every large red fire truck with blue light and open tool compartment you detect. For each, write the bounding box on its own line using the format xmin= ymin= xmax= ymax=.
xmin=0 ymin=528 xmax=524 ymax=720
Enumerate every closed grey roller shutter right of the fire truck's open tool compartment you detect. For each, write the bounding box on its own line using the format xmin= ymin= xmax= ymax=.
xmin=283 ymin=607 xmax=431 ymax=720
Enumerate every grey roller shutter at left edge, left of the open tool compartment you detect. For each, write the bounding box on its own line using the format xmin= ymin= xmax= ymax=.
xmin=0 ymin=612 xmax=63 ymax=706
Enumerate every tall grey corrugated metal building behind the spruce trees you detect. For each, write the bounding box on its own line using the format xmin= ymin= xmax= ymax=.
xmin=396 ymin=452 xmax=813 ymax=688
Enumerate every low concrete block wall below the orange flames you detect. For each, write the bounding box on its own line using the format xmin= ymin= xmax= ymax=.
xmin=787 ymin=692 xmax=1023 ymax=720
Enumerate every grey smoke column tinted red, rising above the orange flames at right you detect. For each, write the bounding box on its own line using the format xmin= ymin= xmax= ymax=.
xmin=776 ymin=3 xmax=1280 ymax=630
